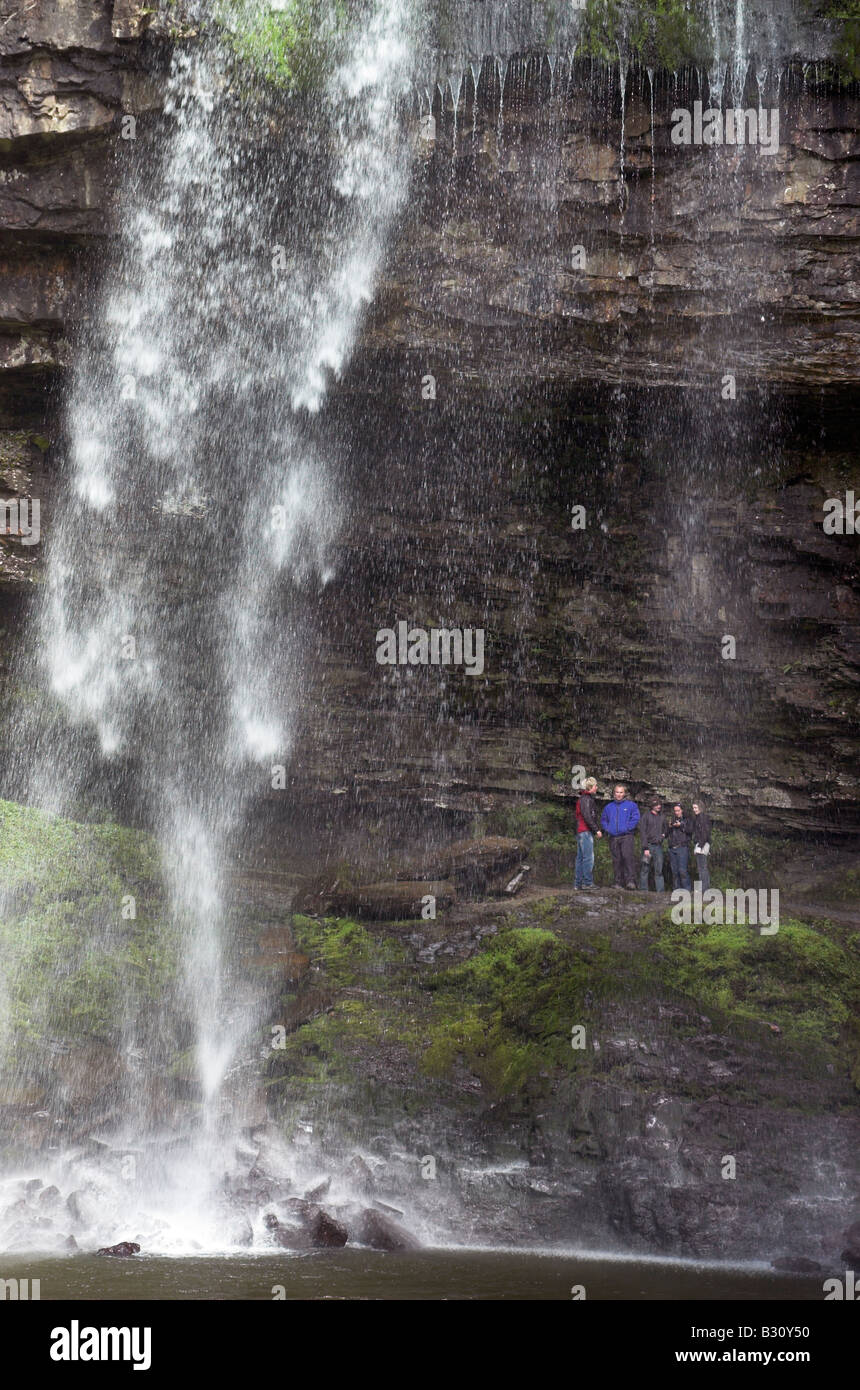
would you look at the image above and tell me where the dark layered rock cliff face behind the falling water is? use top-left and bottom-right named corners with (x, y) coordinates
top-left (0, 0), bottom-right (860, 834)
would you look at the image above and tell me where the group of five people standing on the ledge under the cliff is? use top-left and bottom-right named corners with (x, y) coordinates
top-left (574, 777), bottom-right (711, 892)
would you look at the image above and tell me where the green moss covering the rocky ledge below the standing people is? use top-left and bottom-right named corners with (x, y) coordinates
top-left (268, 894), bottom-right (860, 1099)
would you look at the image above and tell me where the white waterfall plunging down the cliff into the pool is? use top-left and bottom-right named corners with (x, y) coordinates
top-left (0, 0), bottom-right (413, 1245)
